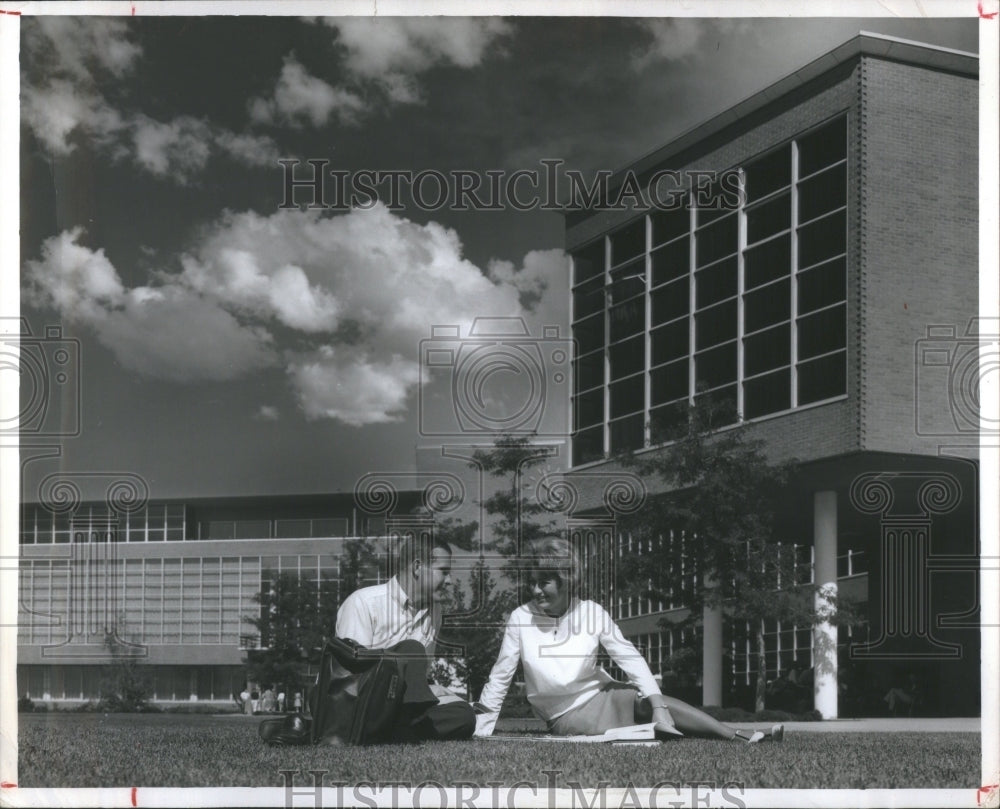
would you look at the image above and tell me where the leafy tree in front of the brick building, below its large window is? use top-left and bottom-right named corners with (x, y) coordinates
top-left (619, 400), bottom-right (861, 710)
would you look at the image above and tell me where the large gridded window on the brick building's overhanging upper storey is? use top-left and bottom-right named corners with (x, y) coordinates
top-left (572, 116), bottom-right (847, 465)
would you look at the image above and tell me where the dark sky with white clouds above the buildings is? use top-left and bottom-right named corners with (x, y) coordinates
top-left (11, 16), bottom-right (978, 499)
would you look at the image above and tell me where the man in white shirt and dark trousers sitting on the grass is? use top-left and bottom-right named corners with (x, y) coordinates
top-left (260, 535), bottom-right (476, 745)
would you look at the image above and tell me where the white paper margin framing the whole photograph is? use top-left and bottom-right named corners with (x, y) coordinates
top-left (0, 0), bottom-right (1000, 807)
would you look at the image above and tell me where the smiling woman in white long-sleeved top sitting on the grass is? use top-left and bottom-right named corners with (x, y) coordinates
top-left (474, 537), bottom-right (784, 743)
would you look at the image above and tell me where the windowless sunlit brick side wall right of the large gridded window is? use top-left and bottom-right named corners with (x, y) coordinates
top-left (859, 57), bottom-right (978, 455)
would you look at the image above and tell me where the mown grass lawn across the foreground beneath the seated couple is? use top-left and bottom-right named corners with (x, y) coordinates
top-left (18, 713), bottom-right (980, 789)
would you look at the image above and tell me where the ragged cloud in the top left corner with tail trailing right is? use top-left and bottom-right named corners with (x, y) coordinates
top-left (22, 16), bottom-right (278, 183)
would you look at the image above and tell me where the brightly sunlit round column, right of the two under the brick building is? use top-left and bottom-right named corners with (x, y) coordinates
top-left (813, 491), bottom-right (837, 719)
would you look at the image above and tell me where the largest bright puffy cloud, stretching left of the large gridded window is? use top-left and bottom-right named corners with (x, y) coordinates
top-left (25, 204), bottom-right (565, 426)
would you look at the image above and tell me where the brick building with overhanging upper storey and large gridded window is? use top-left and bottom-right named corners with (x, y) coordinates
top-left (566, 33), bottom-right (985, 717)
